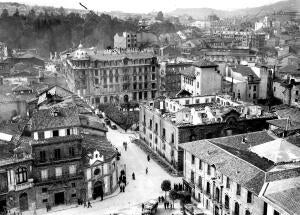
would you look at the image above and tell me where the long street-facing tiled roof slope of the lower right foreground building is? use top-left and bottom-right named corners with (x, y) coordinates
top-left (180, 140), bottom-right (265, 195)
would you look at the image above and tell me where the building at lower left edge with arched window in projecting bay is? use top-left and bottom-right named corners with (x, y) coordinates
top-left (0, 122), bottom-right (35, 214)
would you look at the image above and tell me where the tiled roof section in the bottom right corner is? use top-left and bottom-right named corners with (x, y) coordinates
top-left (265, 187), bottom-right (300, 215)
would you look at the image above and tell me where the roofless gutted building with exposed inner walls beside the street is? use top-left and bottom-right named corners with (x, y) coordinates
top-left (139, 94), bottom-right (275, 171)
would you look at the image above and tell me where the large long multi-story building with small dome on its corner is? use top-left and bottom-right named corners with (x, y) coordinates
top-left (62, 45), bottom-right (160, 105)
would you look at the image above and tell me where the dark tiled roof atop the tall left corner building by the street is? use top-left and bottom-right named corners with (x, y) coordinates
top-left (31, 106), bottom-right (80, 131)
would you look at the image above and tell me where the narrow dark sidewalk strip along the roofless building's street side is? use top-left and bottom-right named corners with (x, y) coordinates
top-left (132, 139), bottom-right (181, 177)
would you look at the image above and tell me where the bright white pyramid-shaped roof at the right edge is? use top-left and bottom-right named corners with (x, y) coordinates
top-left (250, 138), bottom-right (300, 163)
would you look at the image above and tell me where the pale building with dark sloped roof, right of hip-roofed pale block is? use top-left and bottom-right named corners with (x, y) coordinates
top-left (224, 65), bottom-right (272, 102)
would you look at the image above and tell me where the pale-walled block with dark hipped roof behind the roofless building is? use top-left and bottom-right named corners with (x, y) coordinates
top-left (180, 60), bottom-right (222, 96)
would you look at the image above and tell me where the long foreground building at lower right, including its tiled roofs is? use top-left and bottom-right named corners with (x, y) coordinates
top-left (181, 131), bottom-right (300, 215)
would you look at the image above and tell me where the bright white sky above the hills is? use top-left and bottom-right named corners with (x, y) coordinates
top-left (0, 0), bottom-right (286, 13)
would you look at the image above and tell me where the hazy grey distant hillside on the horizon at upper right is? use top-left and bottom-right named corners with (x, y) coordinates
top-left (169, 0), bottom-right (300, 19)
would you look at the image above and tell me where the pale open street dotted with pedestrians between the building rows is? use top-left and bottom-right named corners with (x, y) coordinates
top-left (48, 128), bottom-right (182, 215)
